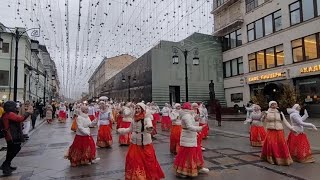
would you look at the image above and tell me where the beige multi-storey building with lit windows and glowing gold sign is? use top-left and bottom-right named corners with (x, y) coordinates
top-left (212, 0), bottom-right (320, 116)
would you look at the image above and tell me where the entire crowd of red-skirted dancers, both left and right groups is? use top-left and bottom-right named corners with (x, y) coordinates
top-left (39, 101), bottom-right (317, 179)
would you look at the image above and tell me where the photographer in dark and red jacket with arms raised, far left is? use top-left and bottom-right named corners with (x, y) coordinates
top-left (1, 101), bottom-right (33, 176)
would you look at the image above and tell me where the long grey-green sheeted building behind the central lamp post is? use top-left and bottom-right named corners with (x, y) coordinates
top-left (103, 33), bottom-right (225, 106)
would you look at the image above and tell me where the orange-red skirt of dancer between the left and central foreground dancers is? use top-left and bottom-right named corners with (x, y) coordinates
top-left (97, 125), bottom-right (112, 147)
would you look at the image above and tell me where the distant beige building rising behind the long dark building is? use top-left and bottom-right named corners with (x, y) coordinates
top-left (88, 54), bottom-right (136, 98)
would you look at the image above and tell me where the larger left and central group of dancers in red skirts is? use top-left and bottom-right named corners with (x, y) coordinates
top-left (53, 101), bottom-right (209, 179)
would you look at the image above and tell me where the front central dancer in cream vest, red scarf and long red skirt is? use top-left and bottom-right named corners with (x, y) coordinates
top-left (118, 103), bottom-right (164, 180)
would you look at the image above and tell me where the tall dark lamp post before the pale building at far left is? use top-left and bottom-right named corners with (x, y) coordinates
top-left (0, 27), bottom-right (40, 101)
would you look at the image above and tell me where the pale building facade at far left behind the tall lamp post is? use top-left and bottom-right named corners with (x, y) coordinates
top-left (0, 23), bottom-right (59, 102)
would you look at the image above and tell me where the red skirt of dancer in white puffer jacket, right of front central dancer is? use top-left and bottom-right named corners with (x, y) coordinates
top-left (173, 146), bottom-right (204, 177)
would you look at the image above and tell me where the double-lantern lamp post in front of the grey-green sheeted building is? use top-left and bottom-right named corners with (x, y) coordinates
top-left (172, 46), bottom-right (199, 102)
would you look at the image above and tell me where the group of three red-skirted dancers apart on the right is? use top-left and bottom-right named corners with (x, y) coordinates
top-left (245, 101), bottom-right (317, 166)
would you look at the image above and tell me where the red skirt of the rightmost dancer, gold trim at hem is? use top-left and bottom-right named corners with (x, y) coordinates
top-left (287, 132), bottom-right (315, 163)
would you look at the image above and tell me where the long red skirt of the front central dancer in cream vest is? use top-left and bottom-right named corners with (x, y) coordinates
top-left (125, 144), bottom-right (164, 180)
